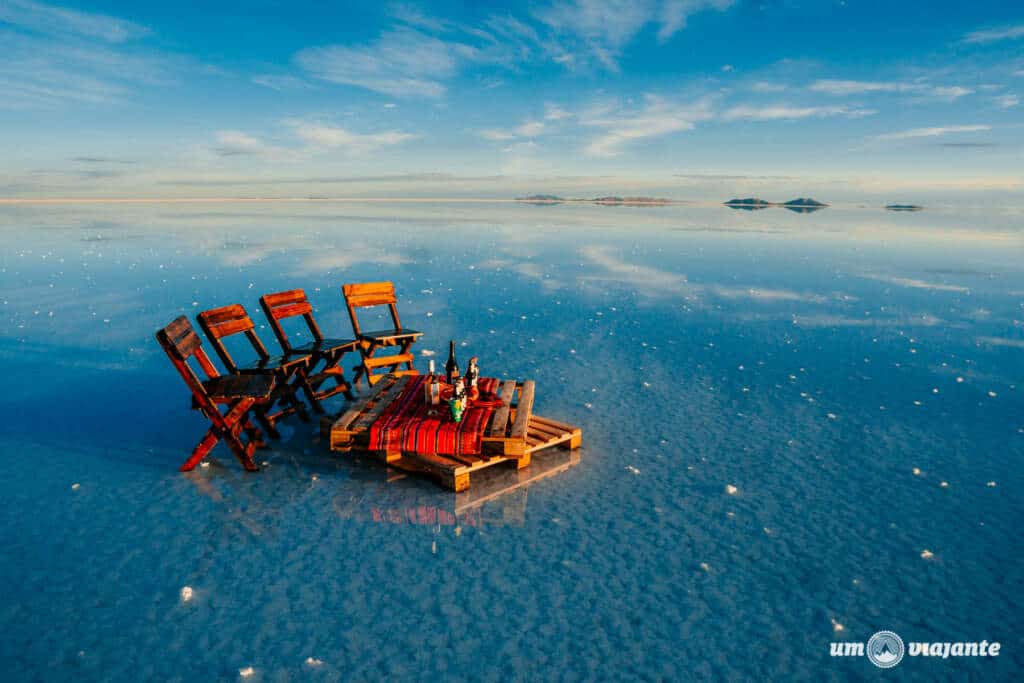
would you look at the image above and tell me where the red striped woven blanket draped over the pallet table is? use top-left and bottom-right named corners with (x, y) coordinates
top-left (370, 375), bottom-right (502, 456)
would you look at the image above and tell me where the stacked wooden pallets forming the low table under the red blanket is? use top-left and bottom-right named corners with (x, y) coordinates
top-left (323, 375), bottom-right (583, 492)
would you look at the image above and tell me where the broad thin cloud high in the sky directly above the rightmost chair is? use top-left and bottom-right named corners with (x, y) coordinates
top-left (295, 28), bottom-right (464, 97)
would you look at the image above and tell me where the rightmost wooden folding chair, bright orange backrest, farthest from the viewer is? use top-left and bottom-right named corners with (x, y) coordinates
top-left (341, 282), bottom-right (423, 386)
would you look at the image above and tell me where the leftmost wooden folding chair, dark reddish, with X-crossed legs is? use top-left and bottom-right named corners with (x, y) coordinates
top-left (157, 315), bottom-right (274, 472)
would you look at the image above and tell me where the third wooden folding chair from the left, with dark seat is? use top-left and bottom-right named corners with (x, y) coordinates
top-left (259, 290), bottom-right (358, 413)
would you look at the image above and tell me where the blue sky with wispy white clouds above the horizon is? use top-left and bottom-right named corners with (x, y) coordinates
top-left (0, 0), bottom-right (1024, 203)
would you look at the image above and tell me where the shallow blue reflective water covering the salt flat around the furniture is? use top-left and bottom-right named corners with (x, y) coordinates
top-left (0, 203), bottom-right (1024, 681)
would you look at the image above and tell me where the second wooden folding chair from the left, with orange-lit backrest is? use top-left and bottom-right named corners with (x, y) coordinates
top-left (197, 303), bottom-right (309, 438)
